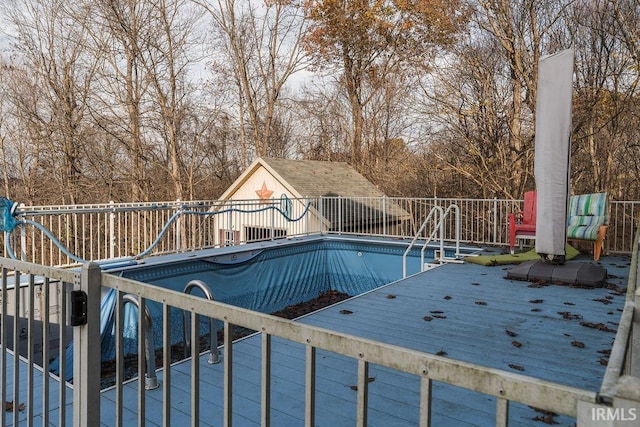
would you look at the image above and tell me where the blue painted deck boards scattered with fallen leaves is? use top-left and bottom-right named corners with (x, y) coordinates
top-left (102, 256), bottom-right (629, 427)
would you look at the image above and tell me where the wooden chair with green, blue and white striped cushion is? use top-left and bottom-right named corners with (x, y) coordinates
top-left (567, 193), bottom-right (609, 261)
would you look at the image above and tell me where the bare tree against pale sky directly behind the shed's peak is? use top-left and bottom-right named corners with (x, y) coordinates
top-left (198, 0), bottom-right (308, 165)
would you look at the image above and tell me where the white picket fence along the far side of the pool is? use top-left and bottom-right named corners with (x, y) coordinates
top-left (0, 197), bottom-right (640, 265)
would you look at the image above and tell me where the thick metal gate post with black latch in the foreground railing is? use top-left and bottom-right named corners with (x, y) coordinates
top-left (71, 263), bottom-right (102, 427)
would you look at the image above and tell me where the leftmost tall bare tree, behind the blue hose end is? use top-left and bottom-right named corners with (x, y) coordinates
top-left (4, 0), bottom-right (94, 203)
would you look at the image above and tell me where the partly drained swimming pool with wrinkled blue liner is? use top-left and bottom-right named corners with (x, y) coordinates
top-left (101, 235), bottom-right (470, 360)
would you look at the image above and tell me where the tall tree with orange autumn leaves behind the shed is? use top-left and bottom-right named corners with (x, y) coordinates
top-left (306, 0), bottom-right (467, 166)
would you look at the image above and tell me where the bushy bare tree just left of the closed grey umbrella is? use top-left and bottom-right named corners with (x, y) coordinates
top-left (421, 36), bottom-right (533, 197)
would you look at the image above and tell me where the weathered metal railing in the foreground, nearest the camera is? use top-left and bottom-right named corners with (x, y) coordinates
top-left (0, 252), bottom-right (638, 426)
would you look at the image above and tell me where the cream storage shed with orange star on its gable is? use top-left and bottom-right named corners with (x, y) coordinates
top-left (216, 158), bottom-right (409, 246)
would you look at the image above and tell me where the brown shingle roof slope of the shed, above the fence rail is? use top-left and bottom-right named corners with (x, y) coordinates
top-left (262, 158), bottom-right (384, 197)
